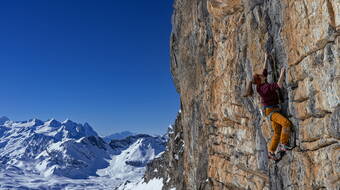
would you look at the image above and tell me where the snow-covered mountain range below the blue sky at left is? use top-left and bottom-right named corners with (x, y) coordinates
top-left (0, 117), bottom-right (166, 189)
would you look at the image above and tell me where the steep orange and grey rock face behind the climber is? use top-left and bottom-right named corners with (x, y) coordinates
top-left (146, 0), bottom-right (340, 190)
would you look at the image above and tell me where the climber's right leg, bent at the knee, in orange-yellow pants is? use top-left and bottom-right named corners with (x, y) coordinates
top-left (271, 112), bottom-right (292, 145)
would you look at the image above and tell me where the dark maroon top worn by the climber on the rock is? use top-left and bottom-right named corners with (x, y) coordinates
top-left (256, 69), bottom-right (280, 106)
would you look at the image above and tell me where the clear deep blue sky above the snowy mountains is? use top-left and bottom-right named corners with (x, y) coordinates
top-left (0, 0), bottom-right (179, 135)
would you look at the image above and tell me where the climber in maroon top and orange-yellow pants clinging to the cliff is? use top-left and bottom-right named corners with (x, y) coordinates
top-left (244, 56), bottom-right (292, 160)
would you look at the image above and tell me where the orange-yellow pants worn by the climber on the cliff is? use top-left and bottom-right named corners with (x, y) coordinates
top-left (265, 108), bottom-right (292, 152)
